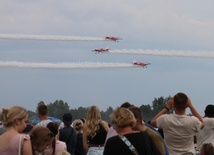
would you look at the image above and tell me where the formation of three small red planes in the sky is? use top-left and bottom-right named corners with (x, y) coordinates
top-left (92, 36), bottom-right (151, 68)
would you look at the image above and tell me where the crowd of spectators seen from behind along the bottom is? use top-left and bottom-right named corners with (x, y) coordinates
top-left (0, 92), bottom-right (214, 155)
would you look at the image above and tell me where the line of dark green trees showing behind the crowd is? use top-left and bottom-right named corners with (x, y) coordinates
top-left (29, 96), bottom-right (170, 123)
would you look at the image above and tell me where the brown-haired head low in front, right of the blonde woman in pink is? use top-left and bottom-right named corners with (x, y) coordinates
top-left (30, 126), bottom-right (54, 152)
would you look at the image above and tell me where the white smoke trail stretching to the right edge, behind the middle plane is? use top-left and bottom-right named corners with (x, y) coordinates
top-left (109, 49), bottom-right (214, 59)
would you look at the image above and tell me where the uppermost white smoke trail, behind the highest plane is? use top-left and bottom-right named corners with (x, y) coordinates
top-left (0, 34), bottom-right (105, 41)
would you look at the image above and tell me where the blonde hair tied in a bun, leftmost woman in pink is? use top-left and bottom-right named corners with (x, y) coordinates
top-left (1, 106), bottom-right (28, 128)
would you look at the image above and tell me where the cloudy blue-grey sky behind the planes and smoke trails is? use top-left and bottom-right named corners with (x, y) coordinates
top-left (0, 0), bottom-right (214, 115)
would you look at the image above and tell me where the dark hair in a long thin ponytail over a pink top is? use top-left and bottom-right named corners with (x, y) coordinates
top-left (47, 122), bottom-right (59, 155)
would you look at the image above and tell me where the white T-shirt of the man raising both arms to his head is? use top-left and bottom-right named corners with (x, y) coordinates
top-left (156, 114), bottom-right (201, 155)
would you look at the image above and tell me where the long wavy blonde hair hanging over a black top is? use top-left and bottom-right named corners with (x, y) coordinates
top-left (86, 106), bottom-right (101, 138)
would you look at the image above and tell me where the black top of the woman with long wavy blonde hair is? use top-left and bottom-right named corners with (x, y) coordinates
top-left (87, 123), bottom-right (107, 145)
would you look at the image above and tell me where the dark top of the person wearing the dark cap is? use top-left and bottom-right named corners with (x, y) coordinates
top-left (59, 126), bottom-right (77, 154)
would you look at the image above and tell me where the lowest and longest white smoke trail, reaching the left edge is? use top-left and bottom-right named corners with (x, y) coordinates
top-left (0, 61), bottom-right (139, 69)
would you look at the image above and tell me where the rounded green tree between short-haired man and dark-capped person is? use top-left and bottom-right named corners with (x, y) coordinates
top-left (47, 100), bottom-right (70, 119)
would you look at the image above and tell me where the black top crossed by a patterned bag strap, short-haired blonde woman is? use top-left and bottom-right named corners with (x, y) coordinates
top-left (103, 132), bottom-right (160, 155)
